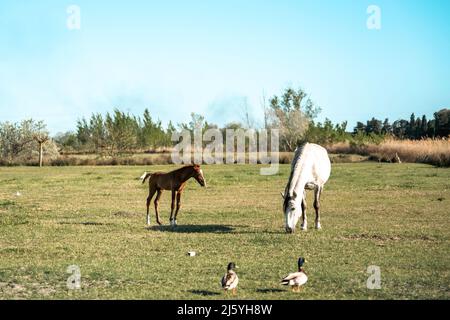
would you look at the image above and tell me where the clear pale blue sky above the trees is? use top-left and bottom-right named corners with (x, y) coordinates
top-left (0, 0), bottom-right (450, 134)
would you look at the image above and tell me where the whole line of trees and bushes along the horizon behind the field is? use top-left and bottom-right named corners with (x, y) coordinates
top-left (0, 88), bottom-right (450, 163)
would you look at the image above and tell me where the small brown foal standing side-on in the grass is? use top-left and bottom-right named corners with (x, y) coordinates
top-left (142, 164), bottom-right (206, 226)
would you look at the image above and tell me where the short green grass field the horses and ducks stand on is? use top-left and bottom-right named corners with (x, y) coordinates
top-left (0, 162), bottom-right (450, 299)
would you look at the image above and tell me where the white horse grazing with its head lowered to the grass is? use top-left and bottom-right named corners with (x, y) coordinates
top-left (281, 143), bottom-right (331, 233)
